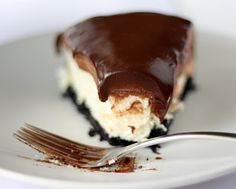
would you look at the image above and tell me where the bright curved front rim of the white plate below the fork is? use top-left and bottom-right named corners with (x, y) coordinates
top-left (0, 161), bottom-right (236, 189)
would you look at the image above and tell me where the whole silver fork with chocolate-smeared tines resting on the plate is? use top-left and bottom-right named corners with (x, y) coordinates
top-left (14, 124), bottom-right (236, 168)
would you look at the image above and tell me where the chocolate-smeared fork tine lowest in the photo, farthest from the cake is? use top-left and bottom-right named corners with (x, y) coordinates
top-left (15, 131), bottom-right (97, 167)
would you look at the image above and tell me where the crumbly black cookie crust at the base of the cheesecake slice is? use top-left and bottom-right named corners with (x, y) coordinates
top-left (63, 78), bottom-right (195, 146)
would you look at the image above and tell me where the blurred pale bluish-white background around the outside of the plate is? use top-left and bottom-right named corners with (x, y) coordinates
top-left (0, 0), bottom-right (236, 189)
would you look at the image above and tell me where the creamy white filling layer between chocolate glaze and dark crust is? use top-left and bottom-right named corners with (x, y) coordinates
top-left (59, 52), bottom-right (184, 141)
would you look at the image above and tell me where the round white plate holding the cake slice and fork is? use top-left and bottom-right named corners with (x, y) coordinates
top-left (0, 33), bottom-right (236, 188)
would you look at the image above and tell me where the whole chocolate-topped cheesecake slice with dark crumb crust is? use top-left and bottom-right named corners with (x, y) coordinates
top-left (56, 12), bottom-right (193, 145)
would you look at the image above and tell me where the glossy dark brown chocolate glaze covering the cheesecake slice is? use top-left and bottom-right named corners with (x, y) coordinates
top-left (57, 12), bottom-right (192, 120)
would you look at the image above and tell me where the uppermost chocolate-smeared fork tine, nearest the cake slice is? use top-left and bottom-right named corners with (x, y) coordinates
top-left (23, 124), bottom-right (106, 156)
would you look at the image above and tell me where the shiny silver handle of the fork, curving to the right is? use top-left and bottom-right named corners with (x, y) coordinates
top-left (121, 131), bottom-right (236, 156)
